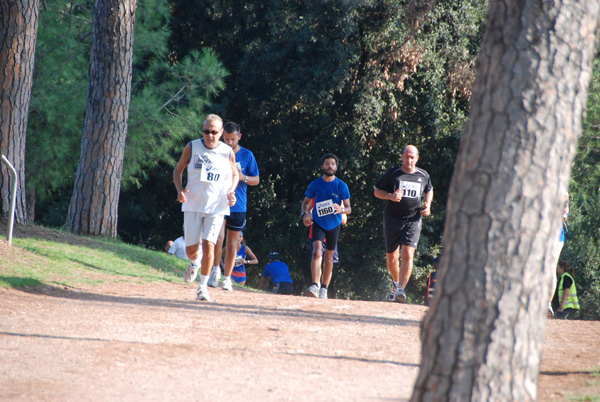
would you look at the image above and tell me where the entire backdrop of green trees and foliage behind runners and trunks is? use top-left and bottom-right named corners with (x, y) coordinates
top-left (27, 0), bottom-right (600, 319)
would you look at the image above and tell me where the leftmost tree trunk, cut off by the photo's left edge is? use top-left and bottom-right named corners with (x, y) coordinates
top-left (0, 0), bottom-right (40, 223)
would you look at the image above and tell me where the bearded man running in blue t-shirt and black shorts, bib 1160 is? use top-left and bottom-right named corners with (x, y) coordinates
top-left (302, 154), bottom-right (352, 299)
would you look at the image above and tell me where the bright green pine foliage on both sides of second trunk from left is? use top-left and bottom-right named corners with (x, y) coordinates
top-left (27, 0), bottom-right (227, 227)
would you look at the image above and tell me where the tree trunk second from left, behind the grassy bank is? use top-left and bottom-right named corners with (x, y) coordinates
top-left (66, 0), bottom-right (136, 237)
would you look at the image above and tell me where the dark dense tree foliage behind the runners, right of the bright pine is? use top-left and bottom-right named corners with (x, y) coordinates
top-left (165, 0), bottom-right (487, 300)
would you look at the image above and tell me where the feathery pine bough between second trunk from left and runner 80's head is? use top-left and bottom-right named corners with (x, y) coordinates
top-left (123, 48), bottom-right (227, 188)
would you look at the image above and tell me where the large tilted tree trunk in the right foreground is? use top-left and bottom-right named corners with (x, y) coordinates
top-left (411, 0), bottom-right (600, 401)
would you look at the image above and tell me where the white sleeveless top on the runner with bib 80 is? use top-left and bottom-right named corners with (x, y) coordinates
top-left (181, 139), bottom-right (233, 215)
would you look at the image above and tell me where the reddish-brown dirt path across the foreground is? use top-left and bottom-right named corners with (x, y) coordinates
top-left (0, 283), bottom-right (600, 402)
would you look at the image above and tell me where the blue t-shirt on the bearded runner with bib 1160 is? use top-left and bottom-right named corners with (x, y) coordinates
top-left (304, 177), bottom-right (350, 230)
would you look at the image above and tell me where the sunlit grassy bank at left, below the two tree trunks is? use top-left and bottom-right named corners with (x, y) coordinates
top-left (0, 235), bottom-right (187, 288)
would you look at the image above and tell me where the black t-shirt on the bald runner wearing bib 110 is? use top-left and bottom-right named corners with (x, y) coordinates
top-left (375, 165), bottom-right (433, 219)
